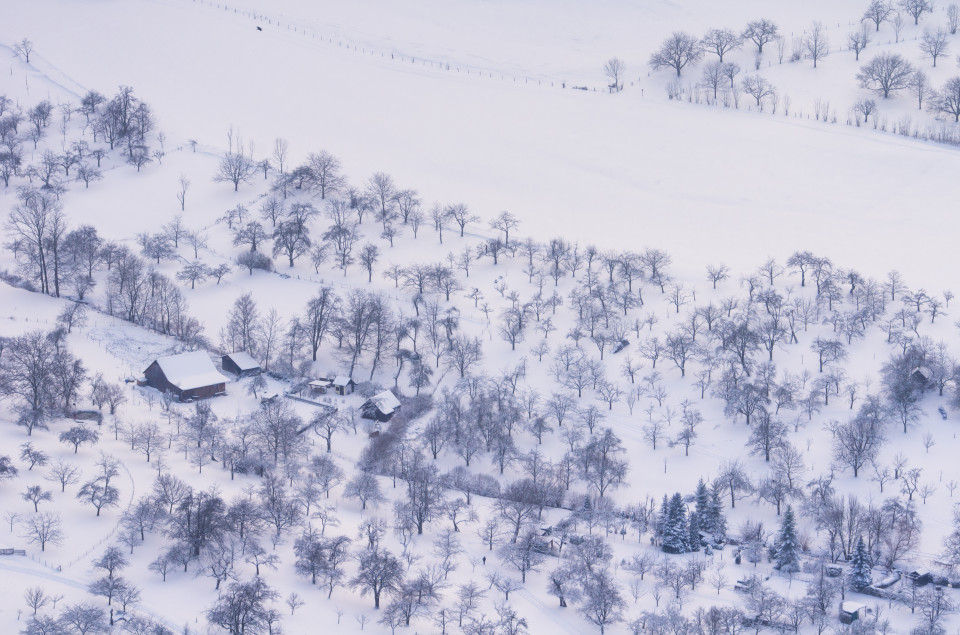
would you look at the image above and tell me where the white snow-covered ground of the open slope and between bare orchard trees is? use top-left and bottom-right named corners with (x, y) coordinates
top-left (0, 0), bottom-right (960, 633)
